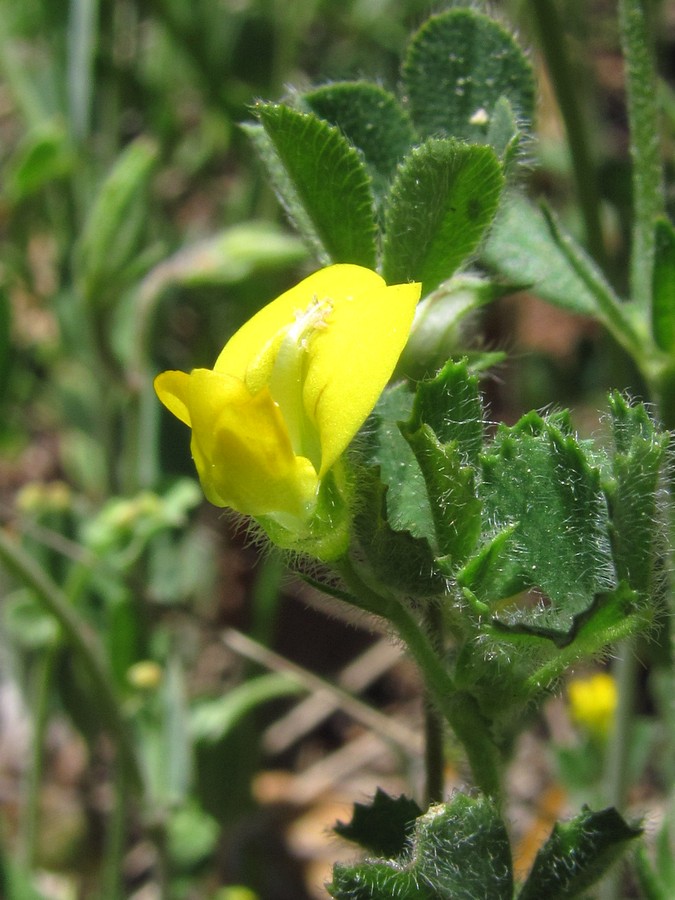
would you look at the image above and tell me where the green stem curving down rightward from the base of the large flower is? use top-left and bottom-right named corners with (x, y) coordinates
top-left (336, 557), bottom-right (501, 799)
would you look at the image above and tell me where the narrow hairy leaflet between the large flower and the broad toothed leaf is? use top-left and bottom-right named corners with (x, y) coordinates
top-left (401, 425), bottom-right (481, 566)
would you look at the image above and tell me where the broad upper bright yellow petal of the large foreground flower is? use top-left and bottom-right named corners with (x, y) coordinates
top-left (214, 264), bottom-right (421, 477)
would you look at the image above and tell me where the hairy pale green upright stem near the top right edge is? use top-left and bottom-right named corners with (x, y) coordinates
top-left (619, 0), bottom-right (664, 314)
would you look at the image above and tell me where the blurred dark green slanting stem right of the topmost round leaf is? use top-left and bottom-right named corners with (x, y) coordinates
top-left (528, 0), bottom-right (606, 267)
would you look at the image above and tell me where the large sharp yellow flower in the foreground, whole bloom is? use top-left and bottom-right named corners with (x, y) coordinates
top-left (155, 265), bottom-right (420, 552)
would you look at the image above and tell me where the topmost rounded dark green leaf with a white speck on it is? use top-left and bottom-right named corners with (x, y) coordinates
top-left (403, 9), bottom-right (535, 143)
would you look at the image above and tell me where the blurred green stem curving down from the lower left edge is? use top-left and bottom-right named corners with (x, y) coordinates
top-left (0, 530), bottom-right (143, 789)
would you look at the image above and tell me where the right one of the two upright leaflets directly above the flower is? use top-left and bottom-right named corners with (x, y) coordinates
top-left (382, 140), bottom-right (504, 296)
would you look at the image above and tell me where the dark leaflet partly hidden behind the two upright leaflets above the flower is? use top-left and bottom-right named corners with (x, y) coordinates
top-left (302, 81), bottom-right (415, 195)
